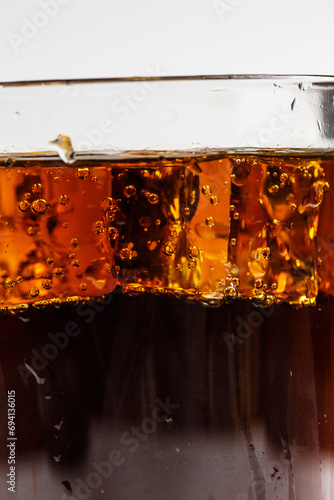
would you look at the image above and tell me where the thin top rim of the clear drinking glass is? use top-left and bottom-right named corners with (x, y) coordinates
top-left (0, 73), bottom-right (334, 87)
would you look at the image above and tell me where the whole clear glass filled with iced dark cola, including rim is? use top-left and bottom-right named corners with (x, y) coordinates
top-left (0, 75), bottom-right (334, 500)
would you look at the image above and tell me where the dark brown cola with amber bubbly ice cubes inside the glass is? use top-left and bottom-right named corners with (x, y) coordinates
top-left (0, 156), bottom-right (334, 500)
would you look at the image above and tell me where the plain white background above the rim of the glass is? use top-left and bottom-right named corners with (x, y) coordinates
top-left (0, 0), bottom-right (334, 81)
